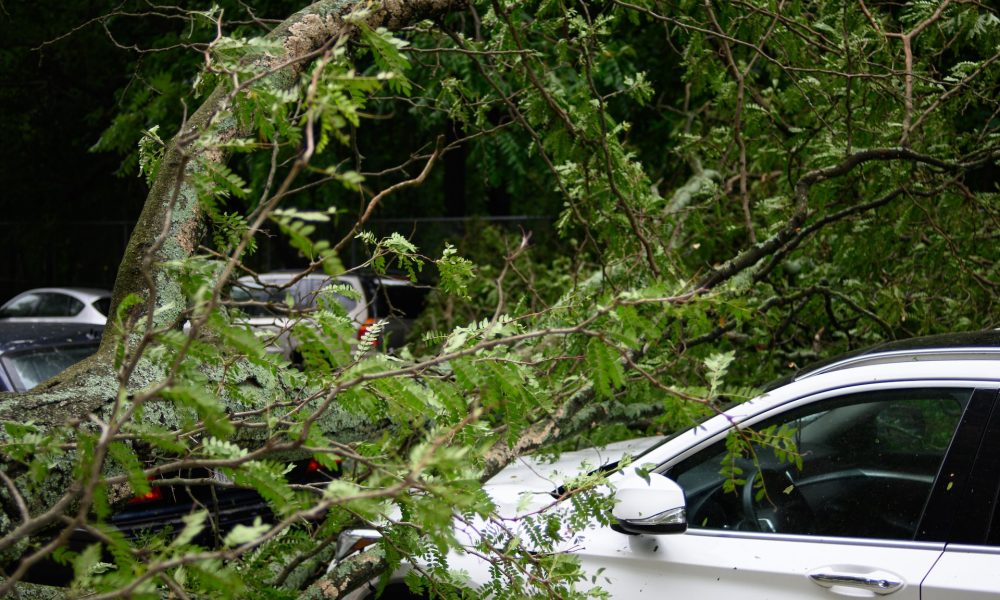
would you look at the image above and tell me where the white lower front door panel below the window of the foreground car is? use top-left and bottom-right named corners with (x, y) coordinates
top-left (576, 528), bottom-right (944, 600)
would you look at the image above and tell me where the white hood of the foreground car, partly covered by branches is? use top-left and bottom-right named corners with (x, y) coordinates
top-left (484, 437), bottom-right (663, 516)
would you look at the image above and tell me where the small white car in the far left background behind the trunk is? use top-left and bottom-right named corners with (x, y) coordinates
top-left (0, 287), bottom-right (111, 325)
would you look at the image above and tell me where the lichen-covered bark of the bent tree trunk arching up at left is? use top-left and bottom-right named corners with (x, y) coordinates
top-left (0, 0), bottom-right (465, 450)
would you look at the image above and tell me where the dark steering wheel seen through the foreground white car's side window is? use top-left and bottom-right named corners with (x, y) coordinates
top-left (741, 468), bottom-right (815, 533)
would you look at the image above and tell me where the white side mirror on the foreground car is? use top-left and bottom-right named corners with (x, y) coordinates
top-left (611, 471), bottom-right (687, 534)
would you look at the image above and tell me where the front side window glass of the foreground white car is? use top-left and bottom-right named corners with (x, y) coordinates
top-left (667, 388), bottom-right (972, 540)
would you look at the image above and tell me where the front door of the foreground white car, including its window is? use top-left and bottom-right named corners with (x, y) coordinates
top-left (580, 383), bottom-right (992, 600)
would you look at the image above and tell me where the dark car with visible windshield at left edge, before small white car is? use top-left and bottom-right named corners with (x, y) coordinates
top-left (0, 321), bottom-right (104, 392)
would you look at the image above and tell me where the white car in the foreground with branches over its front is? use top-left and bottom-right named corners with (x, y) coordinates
top-left (343, 330), bottom-right (1000, 600)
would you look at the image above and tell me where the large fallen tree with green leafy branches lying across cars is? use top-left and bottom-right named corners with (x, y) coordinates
top-left (0, 0), bottom-right (1000, 597)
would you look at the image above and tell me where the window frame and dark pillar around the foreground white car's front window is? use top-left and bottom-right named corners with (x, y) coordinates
top-left (653, 379), bottom-right (1000, 545)
